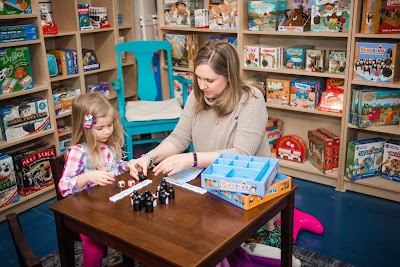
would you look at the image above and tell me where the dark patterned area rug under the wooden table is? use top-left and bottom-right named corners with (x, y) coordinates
top-left (42, 242), bottom-right (354, 267)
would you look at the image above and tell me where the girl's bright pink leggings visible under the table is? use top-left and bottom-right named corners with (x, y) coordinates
top-left (79, 234), bottom-right (105, 267)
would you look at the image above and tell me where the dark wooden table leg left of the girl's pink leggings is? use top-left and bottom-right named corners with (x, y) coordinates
top-left (54, 212), bottom-right (75, 267)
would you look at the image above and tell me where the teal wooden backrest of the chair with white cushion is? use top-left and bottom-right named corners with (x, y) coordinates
top-left (115, 40), bottom-right (175, 118)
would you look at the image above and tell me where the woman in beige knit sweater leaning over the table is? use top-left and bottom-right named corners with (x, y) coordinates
top-left (129, 41), bottom-right (271, 178)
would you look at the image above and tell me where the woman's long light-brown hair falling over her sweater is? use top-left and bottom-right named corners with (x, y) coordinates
top-left (193, 40), bottom-right (264, 116)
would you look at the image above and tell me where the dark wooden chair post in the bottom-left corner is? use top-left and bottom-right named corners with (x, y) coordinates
top-left (6, 213), bottom-right (42, 267)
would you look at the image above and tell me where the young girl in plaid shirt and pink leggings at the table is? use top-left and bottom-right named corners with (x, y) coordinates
top-left (58, 93), bottom-right (136, 267)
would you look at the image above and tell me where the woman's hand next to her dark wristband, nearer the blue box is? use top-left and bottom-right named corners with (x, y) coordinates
top-left (153, 153), bottom-right (193, 176)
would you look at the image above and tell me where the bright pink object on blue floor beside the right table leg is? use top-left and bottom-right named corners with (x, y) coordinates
top-left (276, 209), bottom-right (324, 243)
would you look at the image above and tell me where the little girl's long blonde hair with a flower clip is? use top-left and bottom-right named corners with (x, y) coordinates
top-left (71, 93), bottom-right (124, 170)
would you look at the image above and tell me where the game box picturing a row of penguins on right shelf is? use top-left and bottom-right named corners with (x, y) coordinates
top-left (353, 42), bottom-right (400, 83)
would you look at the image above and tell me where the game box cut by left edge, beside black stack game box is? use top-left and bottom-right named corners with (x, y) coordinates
top-left (0, 153), bottom-right (19, 208)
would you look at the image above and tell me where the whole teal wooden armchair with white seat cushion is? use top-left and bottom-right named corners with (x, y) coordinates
top-left (111, 41), bottom-right (192, 159)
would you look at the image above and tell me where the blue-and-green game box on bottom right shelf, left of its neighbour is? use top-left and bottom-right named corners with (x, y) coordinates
top-left (345, 137), bottom-right (386, 180)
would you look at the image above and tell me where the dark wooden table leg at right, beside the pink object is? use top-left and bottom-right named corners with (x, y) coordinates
top-left (281, 191), bottom-right (294, 267)
